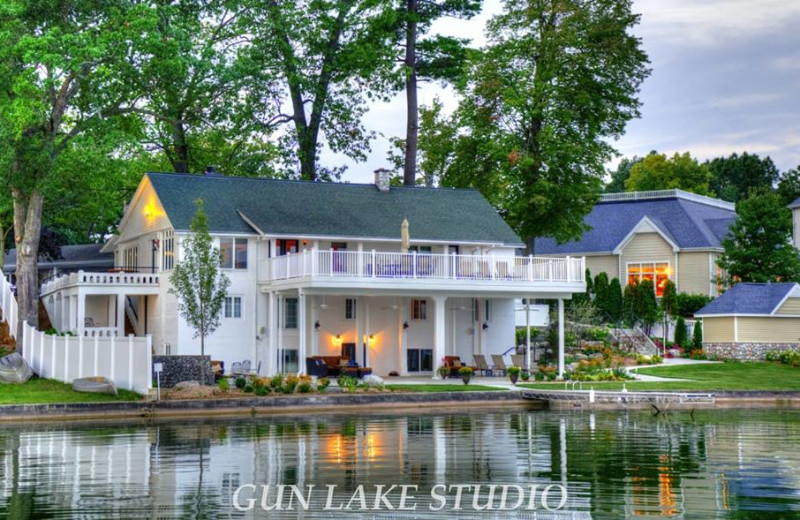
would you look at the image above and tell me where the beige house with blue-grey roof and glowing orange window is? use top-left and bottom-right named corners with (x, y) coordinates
top-left (534, 190), bottom-right (736, 296)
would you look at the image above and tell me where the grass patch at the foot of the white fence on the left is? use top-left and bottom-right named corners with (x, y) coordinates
top-left (0, 378), bottom-right (142, 405)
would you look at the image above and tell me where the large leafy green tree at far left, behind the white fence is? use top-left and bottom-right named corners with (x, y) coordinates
top-left (0, 0), bottom-right (139, 340)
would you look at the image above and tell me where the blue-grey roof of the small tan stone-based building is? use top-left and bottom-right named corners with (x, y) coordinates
top-left (694, 282), bottom-right (797, 316)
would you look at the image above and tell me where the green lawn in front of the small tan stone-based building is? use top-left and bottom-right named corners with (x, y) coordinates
top-left (520, 363), bottom-right (800, 391)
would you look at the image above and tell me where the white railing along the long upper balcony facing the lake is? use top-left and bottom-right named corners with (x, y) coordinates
top-left (260, 250), bottom-right (586, 282)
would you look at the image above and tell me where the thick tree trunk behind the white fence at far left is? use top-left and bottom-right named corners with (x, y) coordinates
top-left (12, 188), bottom-right (43, 354)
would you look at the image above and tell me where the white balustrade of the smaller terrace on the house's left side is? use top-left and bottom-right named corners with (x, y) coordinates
top-left (41, 268), bottom-right (160, 296)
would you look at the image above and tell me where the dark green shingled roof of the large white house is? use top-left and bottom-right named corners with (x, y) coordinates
top-left (148, 173), bottom-right (522, 246)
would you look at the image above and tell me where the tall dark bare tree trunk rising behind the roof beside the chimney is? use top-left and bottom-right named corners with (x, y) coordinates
top-left (403, 0), bottom-right (419, 186)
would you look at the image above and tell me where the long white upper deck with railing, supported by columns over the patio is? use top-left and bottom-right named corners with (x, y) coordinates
top-left (259, 250), bottom-right (586, 293)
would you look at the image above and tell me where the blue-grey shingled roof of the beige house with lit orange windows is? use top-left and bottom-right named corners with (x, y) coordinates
top-left (534, 196), bottom-right (736, 255)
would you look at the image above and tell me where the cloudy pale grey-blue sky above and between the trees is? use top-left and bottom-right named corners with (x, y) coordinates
top-left (323, 0), bottom-right (800, 182)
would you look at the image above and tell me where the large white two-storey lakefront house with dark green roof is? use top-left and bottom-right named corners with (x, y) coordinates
top-left (37, 172), bottom-right (585, 375)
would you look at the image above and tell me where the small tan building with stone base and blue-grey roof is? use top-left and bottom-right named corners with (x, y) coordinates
top-left (695, 282), bottom-right (800, 360)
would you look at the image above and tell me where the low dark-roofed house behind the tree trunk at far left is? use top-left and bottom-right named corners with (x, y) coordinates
top-left (3, 244), bottom-right (114, 281)
